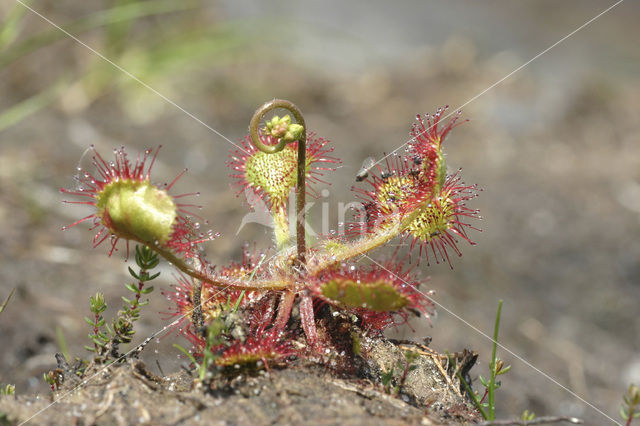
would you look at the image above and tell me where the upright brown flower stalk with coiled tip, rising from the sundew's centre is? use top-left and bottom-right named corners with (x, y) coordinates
top-left (249, 99), bottom-right (307, 265)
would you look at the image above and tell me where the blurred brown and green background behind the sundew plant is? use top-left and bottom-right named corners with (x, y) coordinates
top-left (0, 0), bottom-right (640, 424)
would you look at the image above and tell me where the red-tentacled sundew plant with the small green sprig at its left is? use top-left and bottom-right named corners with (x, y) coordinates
top-left (62, 96), bottom-right (479, 369)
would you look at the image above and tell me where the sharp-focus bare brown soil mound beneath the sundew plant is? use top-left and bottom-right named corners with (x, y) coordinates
top-left (0, 339), bottom-right (479, 425)
